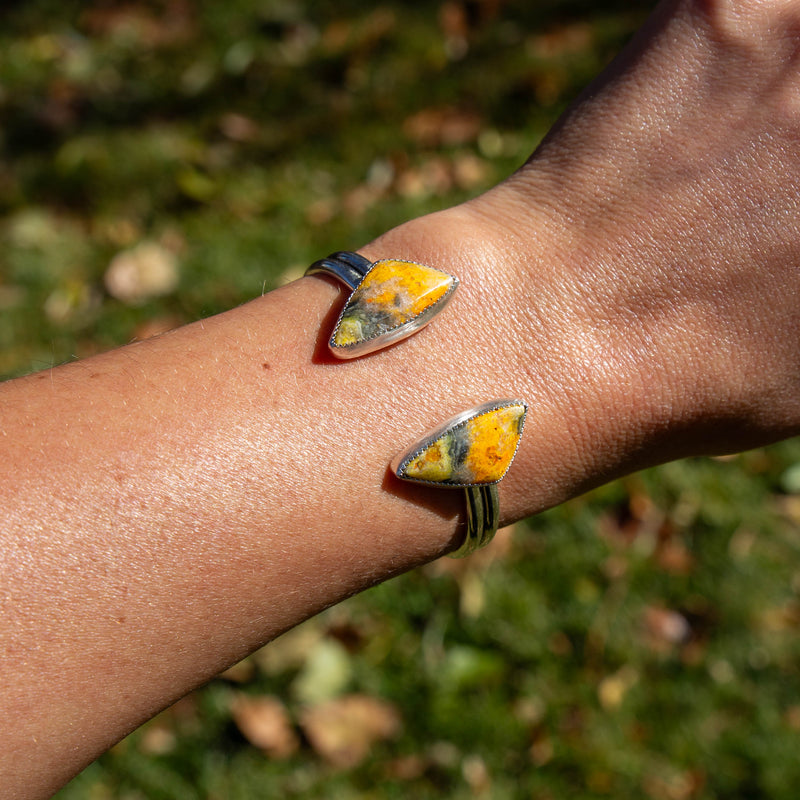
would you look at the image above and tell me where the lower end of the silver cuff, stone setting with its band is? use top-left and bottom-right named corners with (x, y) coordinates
top-left (391, 400), bottom-right (528, 557)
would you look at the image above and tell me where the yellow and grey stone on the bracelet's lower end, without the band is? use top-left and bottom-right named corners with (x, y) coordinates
top-left (397, 403), bottom-right (527, 486)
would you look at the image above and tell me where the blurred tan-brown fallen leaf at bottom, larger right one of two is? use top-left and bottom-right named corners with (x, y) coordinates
top-left (300, 694), bottom-right (401, 769)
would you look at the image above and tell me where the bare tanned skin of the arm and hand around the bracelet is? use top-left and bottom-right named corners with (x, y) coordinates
top-left (0, 0), bottom-right (800, 798)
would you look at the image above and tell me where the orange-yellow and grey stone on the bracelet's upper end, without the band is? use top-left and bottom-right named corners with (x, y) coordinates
top-left (331, 259), bottom-right (455, 347)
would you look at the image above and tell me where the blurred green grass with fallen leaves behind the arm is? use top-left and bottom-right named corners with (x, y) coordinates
top-left (0, 0), bottom-right (800, 800)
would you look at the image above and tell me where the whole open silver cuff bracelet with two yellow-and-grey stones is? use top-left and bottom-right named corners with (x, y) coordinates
top-left (306, 251), bottom-right (528, 557)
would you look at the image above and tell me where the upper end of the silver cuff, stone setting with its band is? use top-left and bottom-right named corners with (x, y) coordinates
top-left (306, 251), bottom-right (458, 358)
